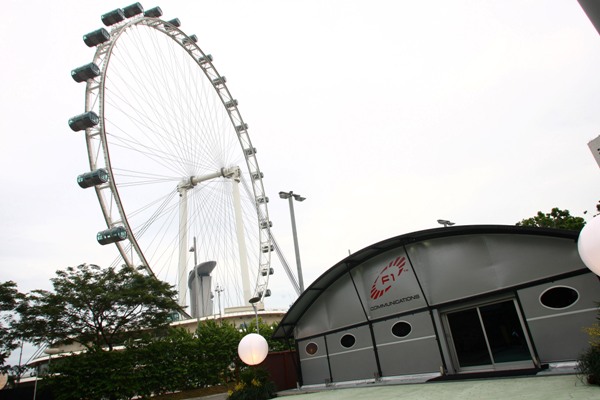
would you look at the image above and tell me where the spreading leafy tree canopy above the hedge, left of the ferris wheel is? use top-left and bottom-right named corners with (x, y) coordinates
top-left (18, 264), bottom-right (178, 350)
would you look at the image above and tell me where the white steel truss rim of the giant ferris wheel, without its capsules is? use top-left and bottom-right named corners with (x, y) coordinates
top-left (79, 11), bottom-right (271, 306)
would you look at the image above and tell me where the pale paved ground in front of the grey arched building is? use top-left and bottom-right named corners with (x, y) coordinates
top-left (280, 375), bottom-right (600, 400)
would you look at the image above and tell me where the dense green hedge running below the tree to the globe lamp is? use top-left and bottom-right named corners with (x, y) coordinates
top-left (41, 320), bottom-right (286, 400)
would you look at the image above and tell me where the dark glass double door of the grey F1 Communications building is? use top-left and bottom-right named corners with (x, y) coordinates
top-left (445, 300), bottom-right (534, 370)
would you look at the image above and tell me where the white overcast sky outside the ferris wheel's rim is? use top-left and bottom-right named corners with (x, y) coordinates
top-left (0, 0), bottom-right (600, 324)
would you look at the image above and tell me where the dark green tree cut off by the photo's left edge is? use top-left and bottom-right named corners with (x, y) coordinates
top-left (0, 281), bottom-right (22, 371)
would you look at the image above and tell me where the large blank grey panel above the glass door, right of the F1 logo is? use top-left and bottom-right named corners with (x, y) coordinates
top-left (407, 234), bottom-right (584, 305)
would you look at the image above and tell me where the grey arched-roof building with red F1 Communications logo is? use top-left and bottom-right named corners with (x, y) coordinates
top-left (275, 226), bottom-right (600, 385)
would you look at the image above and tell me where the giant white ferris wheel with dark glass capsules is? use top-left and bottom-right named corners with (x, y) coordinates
top-left (69, 3), bottom-right (273, 312)
